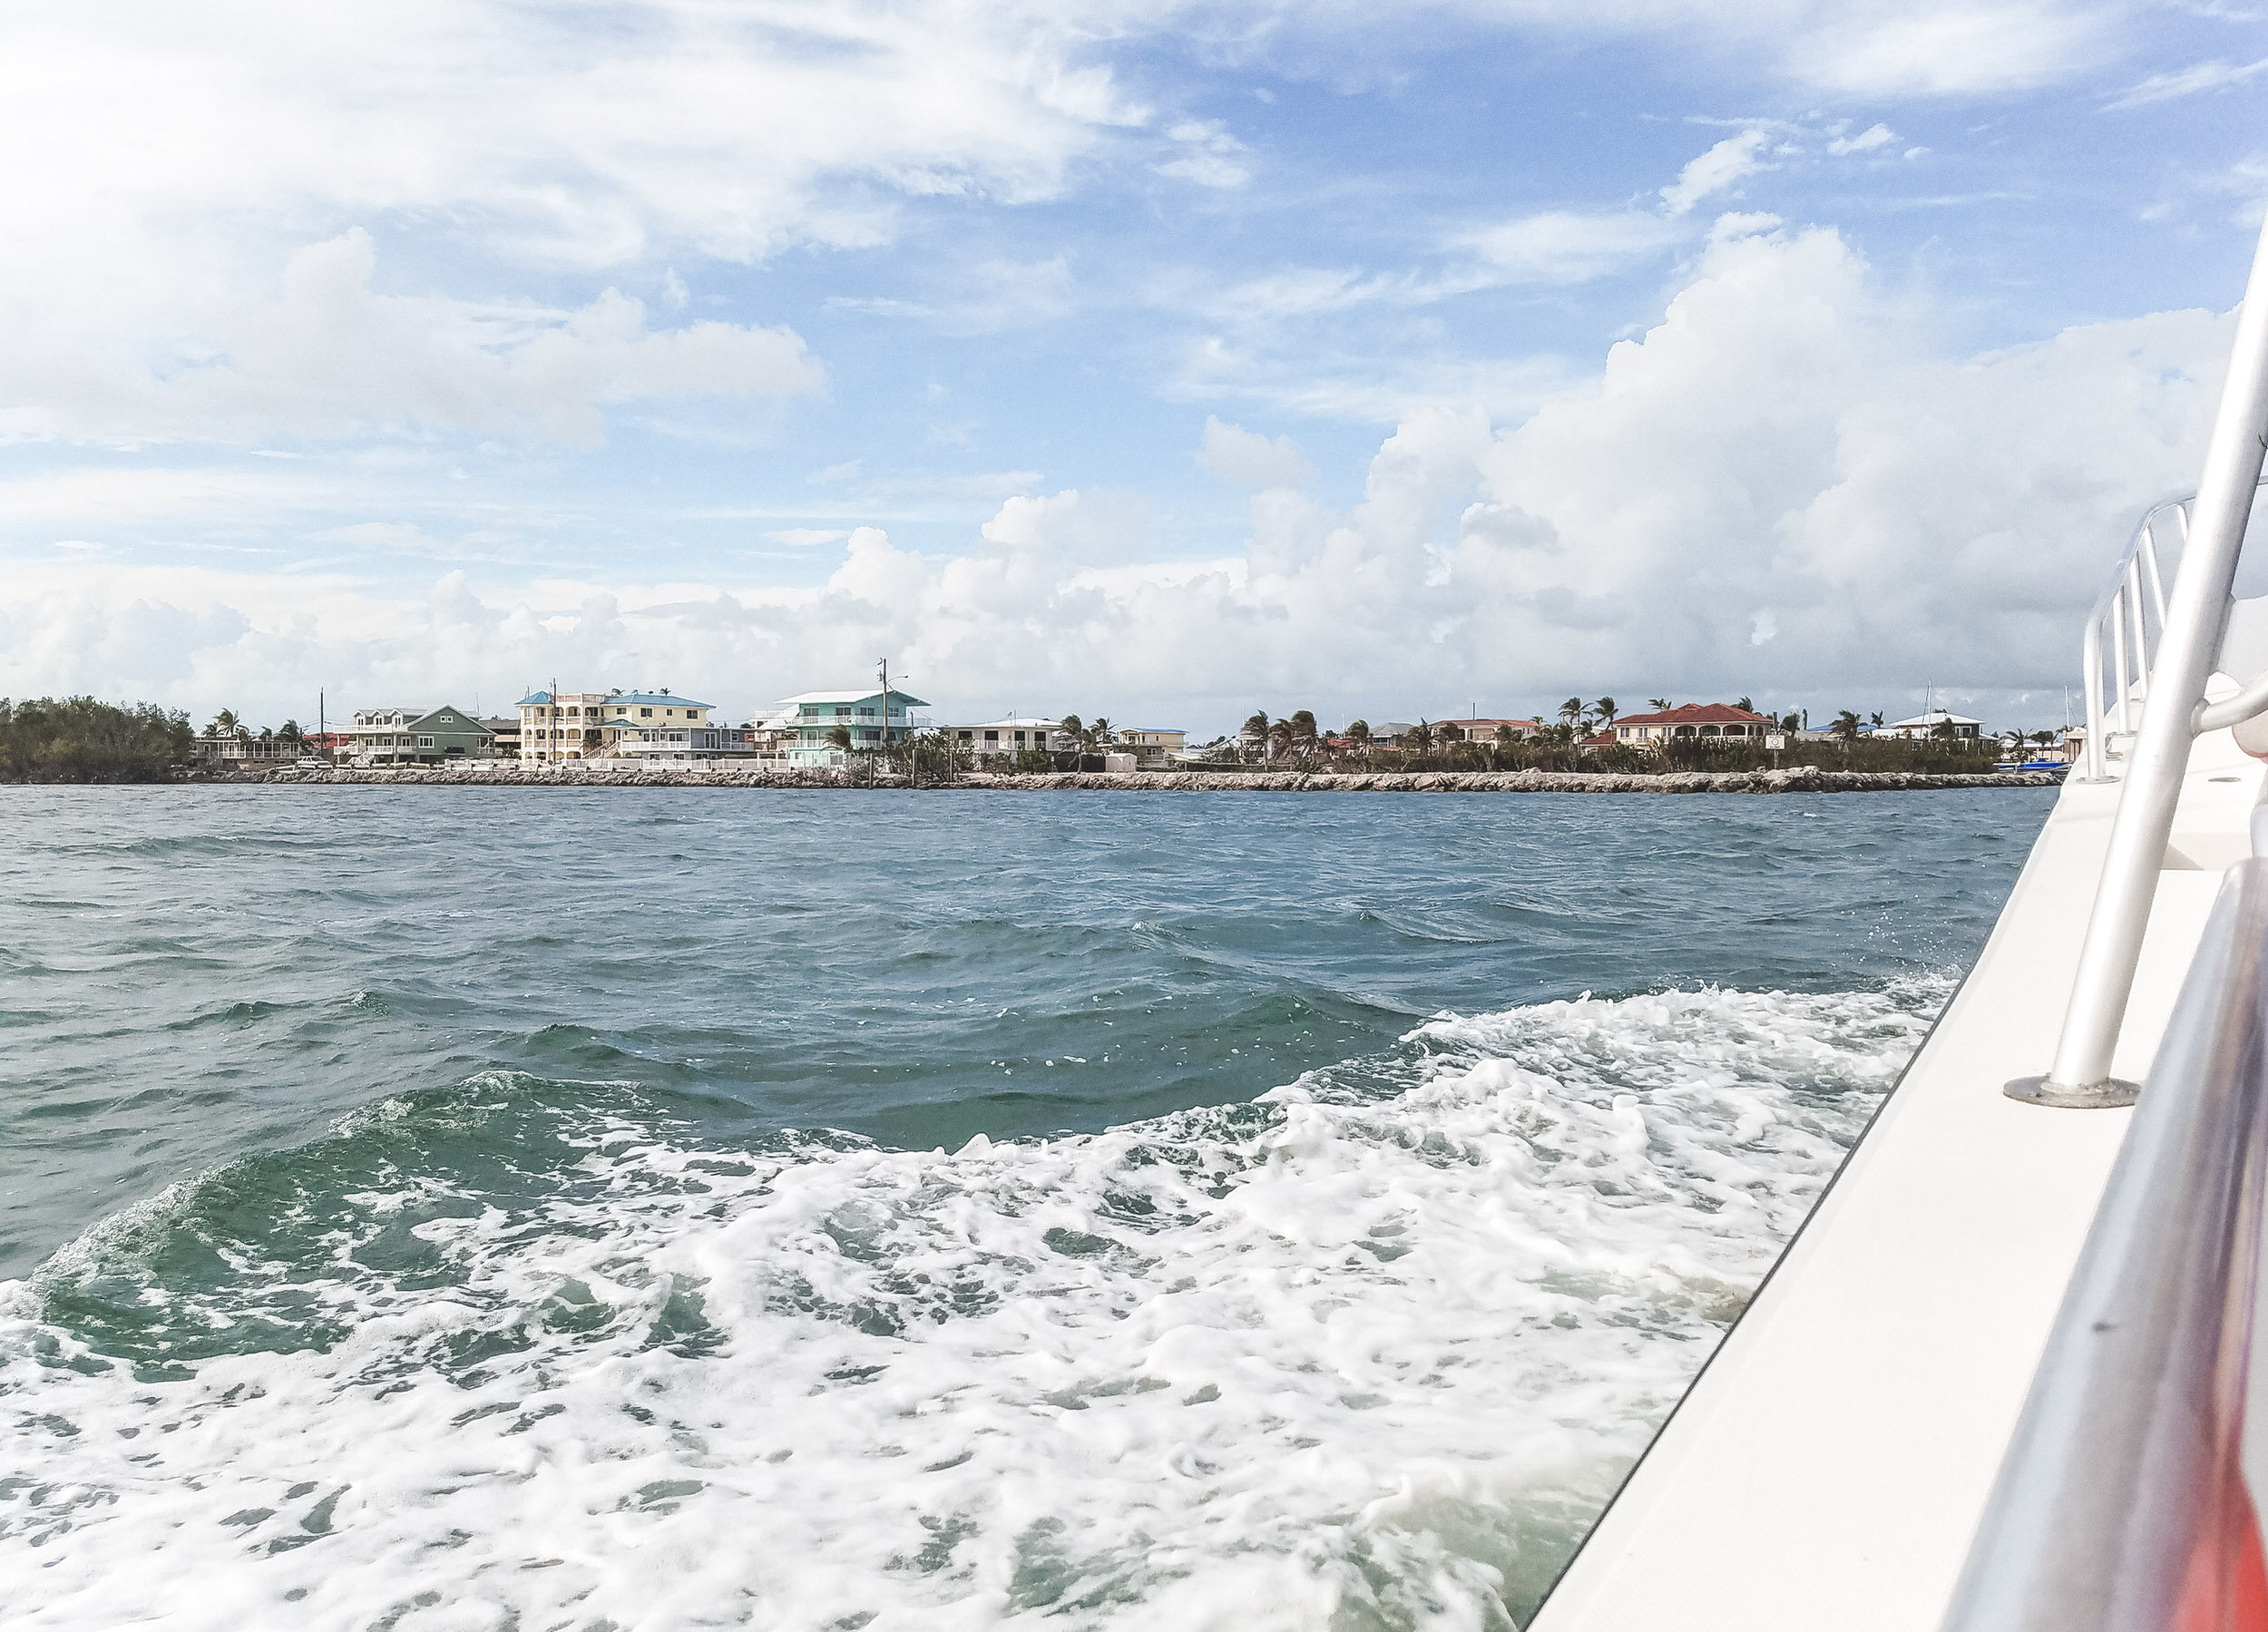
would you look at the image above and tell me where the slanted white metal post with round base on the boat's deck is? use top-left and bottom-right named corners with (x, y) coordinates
top-left (2008, 210), bottom-right (2268, 1106)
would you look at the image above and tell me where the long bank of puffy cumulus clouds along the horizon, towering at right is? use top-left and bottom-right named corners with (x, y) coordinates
top-left (0, 229), bottom-right (2230, 726)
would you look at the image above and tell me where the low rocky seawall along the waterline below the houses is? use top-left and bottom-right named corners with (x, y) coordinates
top-left (189, 764), bottom-right (2055, 794)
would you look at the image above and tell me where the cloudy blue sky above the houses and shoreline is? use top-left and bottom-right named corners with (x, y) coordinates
top-left (0, 0), bottom-right (2268, 737)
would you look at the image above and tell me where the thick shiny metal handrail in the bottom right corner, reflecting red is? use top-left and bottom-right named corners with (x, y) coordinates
top-left (1944, 861), bottom-right (2268, 1632)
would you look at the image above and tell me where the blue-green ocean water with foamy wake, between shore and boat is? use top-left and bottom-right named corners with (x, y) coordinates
top-left (0, 787), bottom-right (2053, 1632)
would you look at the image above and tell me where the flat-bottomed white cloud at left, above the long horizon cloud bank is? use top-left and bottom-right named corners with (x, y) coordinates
top-left (0, 229), bottom-right (824, 442)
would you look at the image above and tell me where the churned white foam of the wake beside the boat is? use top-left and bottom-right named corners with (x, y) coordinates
top-left (0, 991), bottom-right (1941, 1632)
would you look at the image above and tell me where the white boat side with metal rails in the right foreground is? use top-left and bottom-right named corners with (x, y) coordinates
top-left (1531, 210), bottom-right (2268, 1632)
